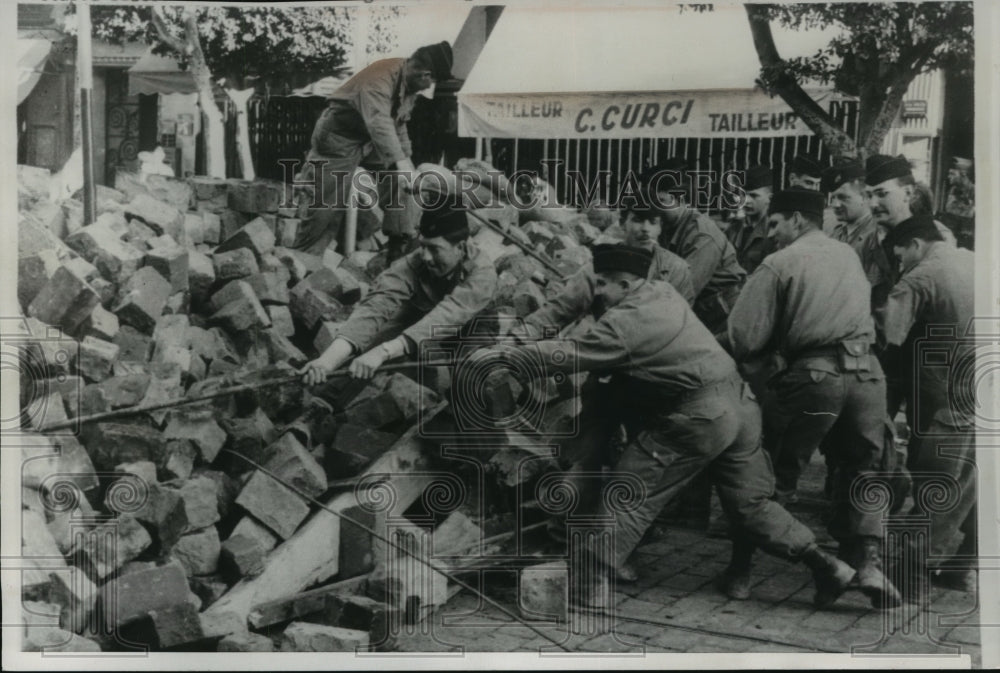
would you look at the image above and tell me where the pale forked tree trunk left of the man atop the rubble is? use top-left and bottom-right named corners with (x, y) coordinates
top-left (153, 6), bottom-right (226, 178)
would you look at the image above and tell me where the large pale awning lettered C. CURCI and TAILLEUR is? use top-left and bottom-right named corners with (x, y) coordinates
top-left (458, 5), bottom-right (834, 139)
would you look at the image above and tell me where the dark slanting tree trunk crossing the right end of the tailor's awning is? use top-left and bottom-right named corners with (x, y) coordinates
top-left (745, 4), bottom-right (858, 158)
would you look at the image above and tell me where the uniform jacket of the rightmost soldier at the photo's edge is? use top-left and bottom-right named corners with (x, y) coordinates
top-left (879, 242), bottom-right (975, 429)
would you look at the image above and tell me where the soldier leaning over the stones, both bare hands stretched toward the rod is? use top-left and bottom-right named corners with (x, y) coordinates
top-left (302, 201), bottom-right (497, 385)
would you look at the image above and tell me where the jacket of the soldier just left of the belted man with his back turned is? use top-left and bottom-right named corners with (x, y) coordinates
top-left (660, 209), bottom-right (746, 299)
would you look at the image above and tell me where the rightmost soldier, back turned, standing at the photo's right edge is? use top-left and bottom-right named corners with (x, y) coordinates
top-left (882, 215), bottom-right (977, 591)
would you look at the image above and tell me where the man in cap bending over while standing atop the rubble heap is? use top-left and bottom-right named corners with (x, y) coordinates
top-left (295, 42), bottom-right (452, 261)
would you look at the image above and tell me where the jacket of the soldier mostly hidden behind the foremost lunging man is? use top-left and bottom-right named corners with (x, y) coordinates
top-left (524, 245), bottom-right (694, 335)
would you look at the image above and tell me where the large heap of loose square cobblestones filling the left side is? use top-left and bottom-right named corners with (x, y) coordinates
top-left (17, 159), bottom-right (600, 651)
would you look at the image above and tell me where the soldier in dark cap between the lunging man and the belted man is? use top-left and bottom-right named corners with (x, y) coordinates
top-left (640, 168), bottom-right (746, 334)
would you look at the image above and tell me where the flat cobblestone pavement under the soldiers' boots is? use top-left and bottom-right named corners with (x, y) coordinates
top-left (397, 446), bottom-right (980, 667)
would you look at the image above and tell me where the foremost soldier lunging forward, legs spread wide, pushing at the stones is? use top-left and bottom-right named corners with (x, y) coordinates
top-left (508, 245), bottom-right (854, 604)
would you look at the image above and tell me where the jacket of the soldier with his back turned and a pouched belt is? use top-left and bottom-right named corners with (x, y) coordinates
top-left (728, 230), bottom-right (875, 361)
